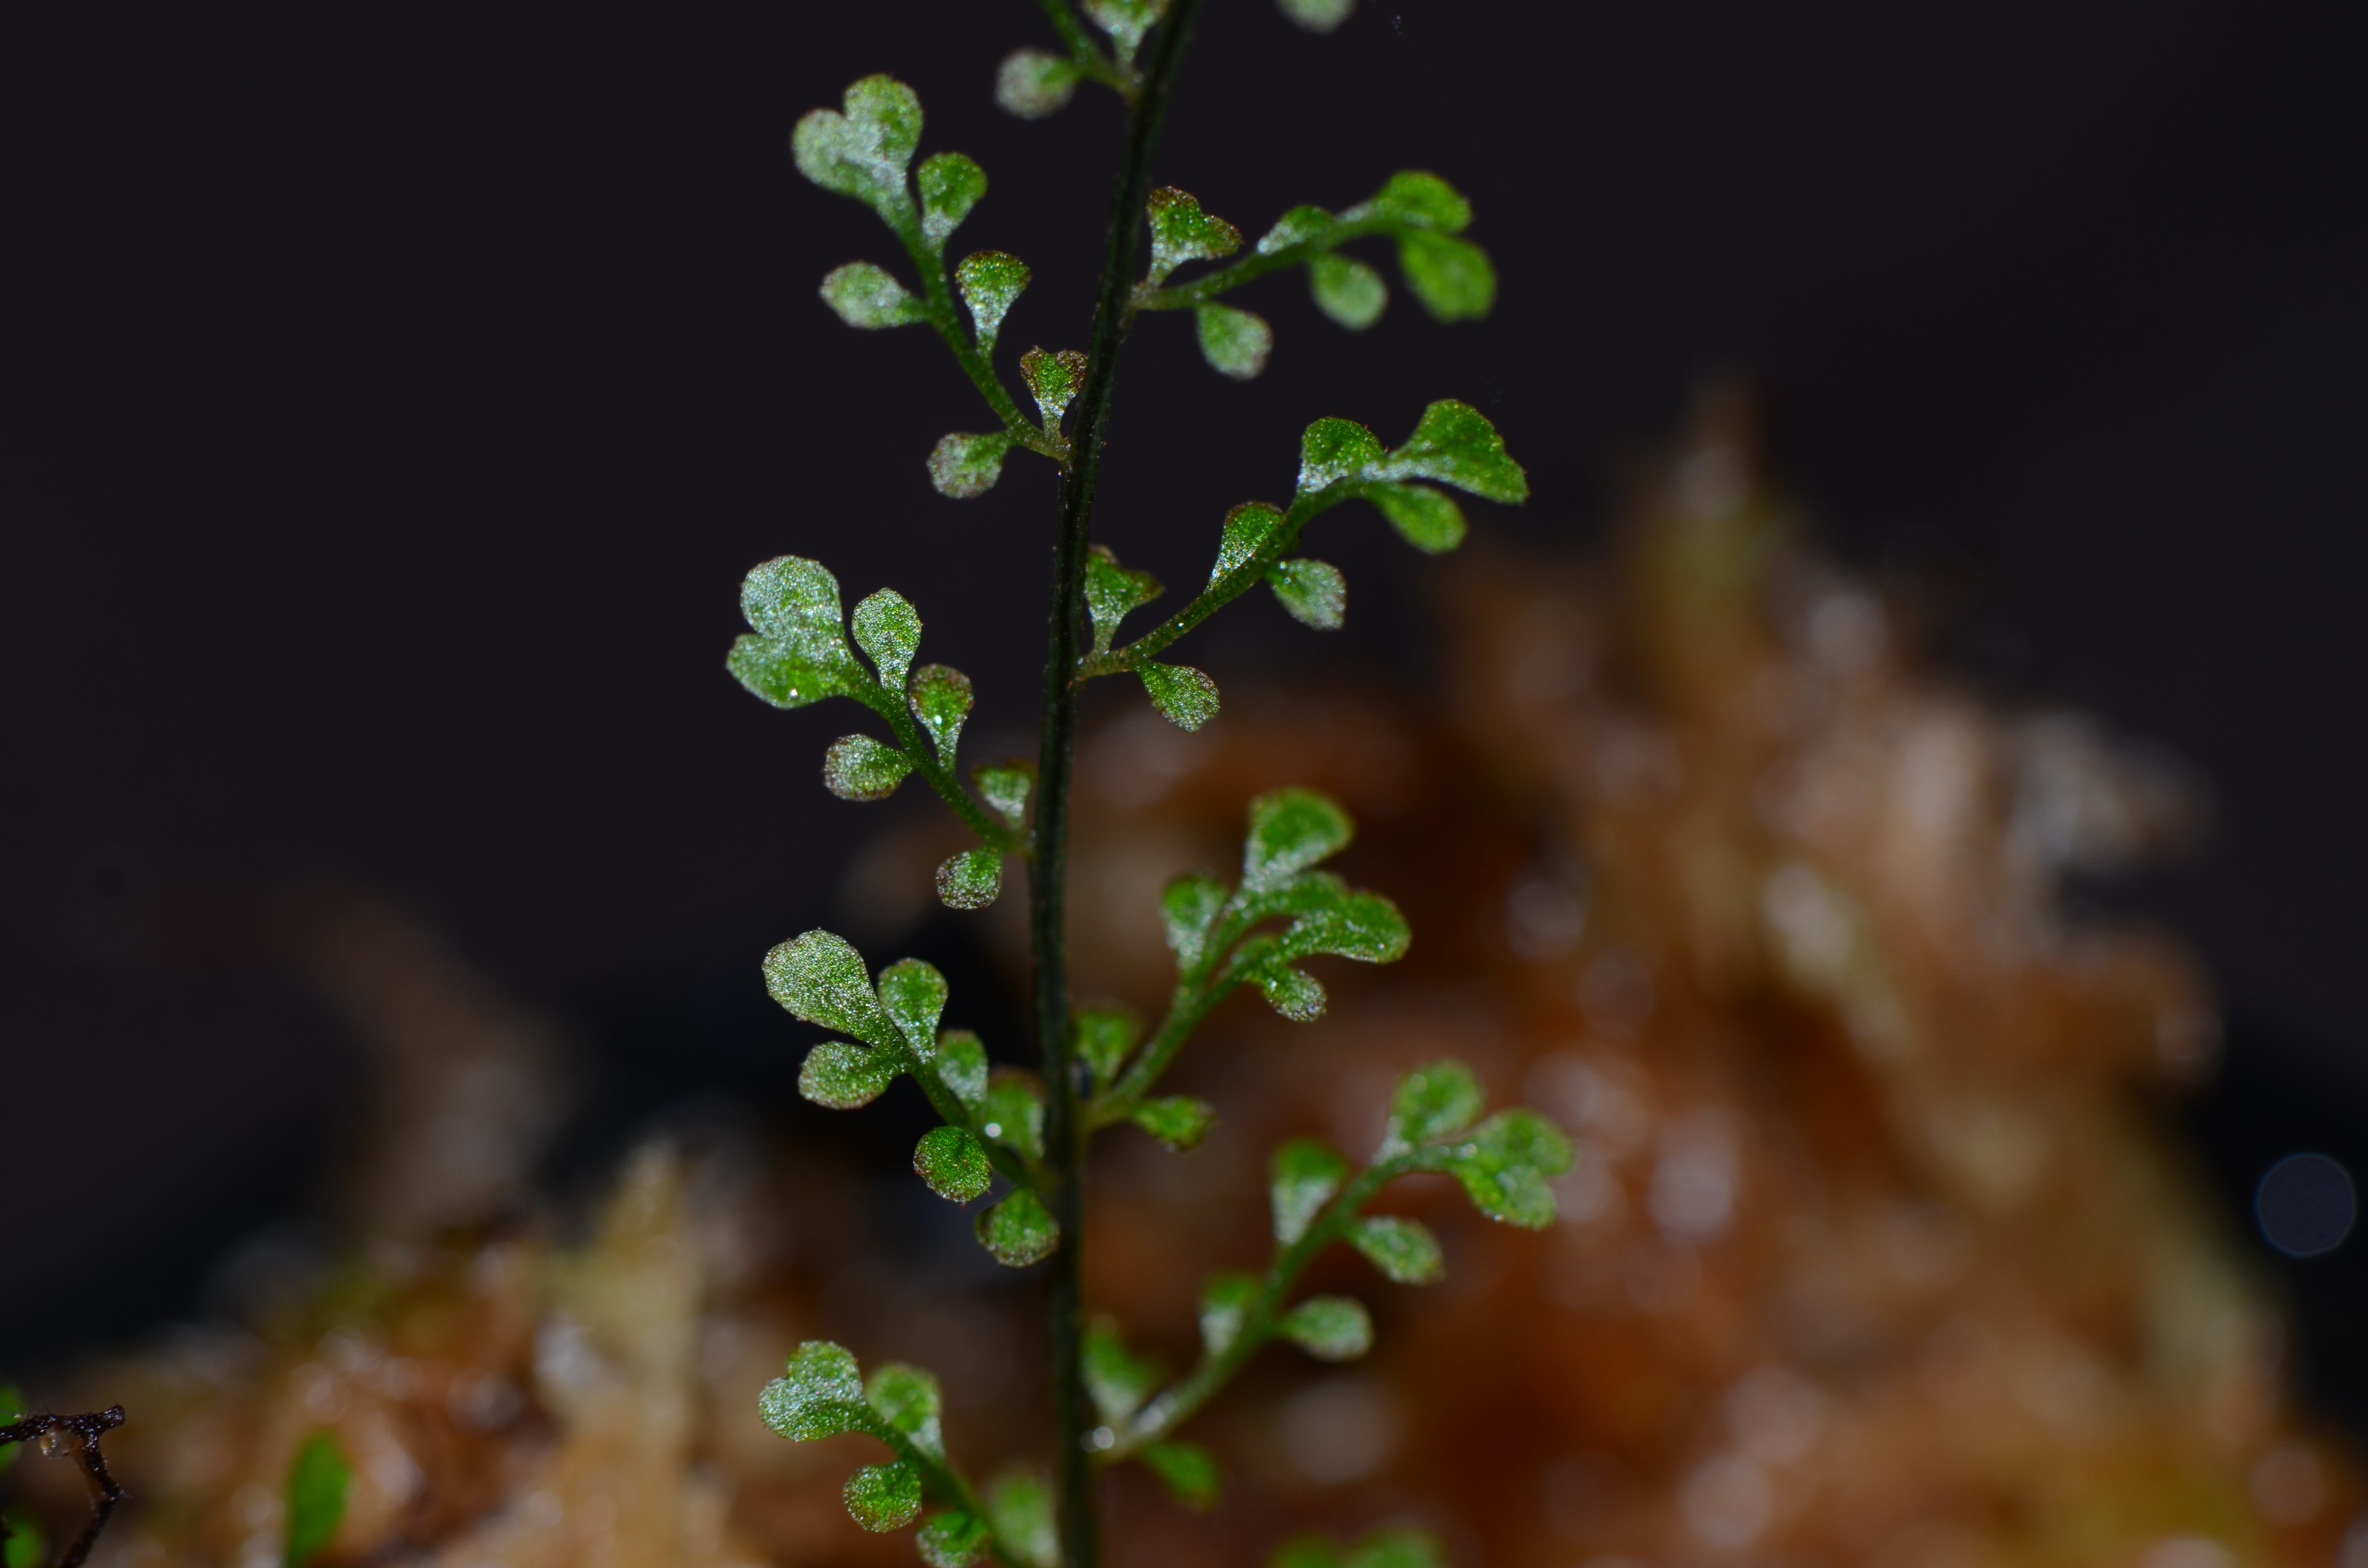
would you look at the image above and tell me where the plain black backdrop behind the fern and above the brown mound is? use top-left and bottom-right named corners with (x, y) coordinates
top-left (0, 0), bottom-right (2368, 1402)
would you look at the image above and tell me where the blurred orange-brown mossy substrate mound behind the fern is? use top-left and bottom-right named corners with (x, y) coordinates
top-left (13, 395), bottom-right (2363, 1568)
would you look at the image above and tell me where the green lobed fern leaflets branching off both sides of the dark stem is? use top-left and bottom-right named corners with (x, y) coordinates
top-left (727, 0), bottom-right (1570, 1568)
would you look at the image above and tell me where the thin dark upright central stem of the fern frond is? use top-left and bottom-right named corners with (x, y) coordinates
top-left (1028, 12), bottom-right (1200, 1568)
